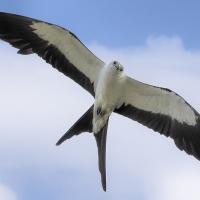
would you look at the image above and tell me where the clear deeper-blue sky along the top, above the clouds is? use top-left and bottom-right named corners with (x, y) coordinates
top-left (0, 0), bottom-right (200, 48)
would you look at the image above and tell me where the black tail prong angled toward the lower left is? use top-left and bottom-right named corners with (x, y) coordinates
top-left (56, 105), bottom-right (94, 145)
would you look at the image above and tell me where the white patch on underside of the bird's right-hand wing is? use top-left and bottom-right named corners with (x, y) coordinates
top-left (125, 77), bottom-right (197, 126)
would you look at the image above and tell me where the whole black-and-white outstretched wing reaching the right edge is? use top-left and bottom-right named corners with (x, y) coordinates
top-left (115, 77), bottom-right (200, 160)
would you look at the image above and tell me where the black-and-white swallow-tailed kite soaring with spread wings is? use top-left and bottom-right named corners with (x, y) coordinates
top-left (0, 12), bottom-right (200, 191)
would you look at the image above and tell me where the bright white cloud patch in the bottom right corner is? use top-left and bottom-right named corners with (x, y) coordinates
top-left (152, 168), bottom-right (200, 200)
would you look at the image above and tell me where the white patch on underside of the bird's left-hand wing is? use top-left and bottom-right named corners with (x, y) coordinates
top-left (31, 22), bottom-right (104, 83)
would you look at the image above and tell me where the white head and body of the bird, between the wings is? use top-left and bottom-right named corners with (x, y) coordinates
top-left (93, 61), bottom-right (125, 133)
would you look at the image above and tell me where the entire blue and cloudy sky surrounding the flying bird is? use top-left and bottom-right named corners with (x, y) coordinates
top-left (0, 0), bottom-right (200, 200)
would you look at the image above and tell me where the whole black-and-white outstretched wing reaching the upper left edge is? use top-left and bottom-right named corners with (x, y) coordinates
top-left (0, 12), bottom-right (104, 96)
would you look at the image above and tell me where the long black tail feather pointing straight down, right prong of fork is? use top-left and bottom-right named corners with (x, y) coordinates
top-left (94, 121), bottom-right (108, 191)
